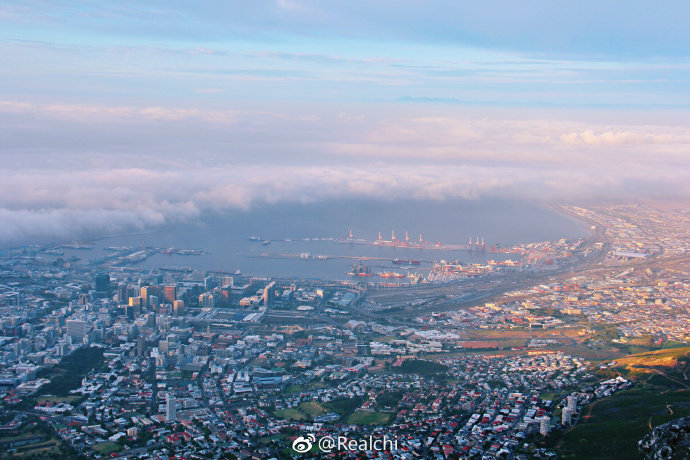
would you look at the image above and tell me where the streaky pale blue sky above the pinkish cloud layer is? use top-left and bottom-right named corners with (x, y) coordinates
top-left (0, 0), bottom-right (690, 108)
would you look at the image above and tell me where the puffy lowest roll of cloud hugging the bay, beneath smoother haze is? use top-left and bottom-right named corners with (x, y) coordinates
top-left (0, 164), bottom-right (690, 245)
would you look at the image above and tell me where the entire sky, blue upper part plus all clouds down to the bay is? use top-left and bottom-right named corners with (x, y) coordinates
top-left (0, 0), bottom-right (690, 244)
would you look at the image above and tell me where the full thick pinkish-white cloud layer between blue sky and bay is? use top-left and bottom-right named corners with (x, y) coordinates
top-left (0, 102), bottom-right (690, 244)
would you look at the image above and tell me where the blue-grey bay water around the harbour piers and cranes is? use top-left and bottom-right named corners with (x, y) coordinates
top-left (55, 199), bottom-right (587, 281)
